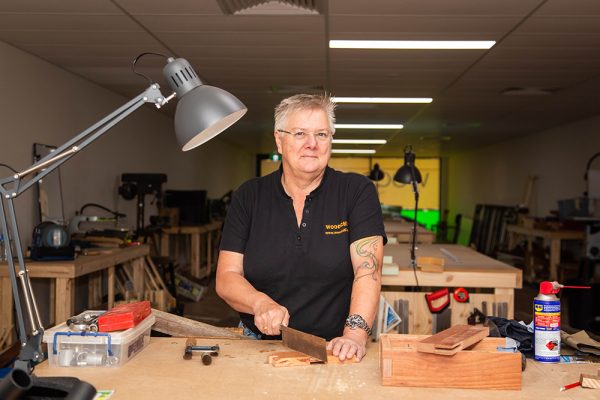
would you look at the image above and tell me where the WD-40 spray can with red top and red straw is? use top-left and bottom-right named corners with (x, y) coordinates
top-left (533, 281), bottom-right (591, 363)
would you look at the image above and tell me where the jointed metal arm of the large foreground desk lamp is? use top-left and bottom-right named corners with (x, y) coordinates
top-left (0, 84), bottom-right (175, 374)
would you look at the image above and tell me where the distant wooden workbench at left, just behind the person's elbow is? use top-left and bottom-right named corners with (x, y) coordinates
top-left (160, 221), bottom-right (223, 279)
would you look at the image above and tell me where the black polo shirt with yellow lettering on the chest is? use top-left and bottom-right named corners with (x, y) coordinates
top-left (220, 167), bottom-right (387, 340)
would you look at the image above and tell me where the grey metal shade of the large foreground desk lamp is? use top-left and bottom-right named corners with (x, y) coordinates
top-left (163, 58), bottom-right (248, 151)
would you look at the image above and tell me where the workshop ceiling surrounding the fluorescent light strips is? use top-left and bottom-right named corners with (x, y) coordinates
top-left (0, 0), bottom-right (600, 157)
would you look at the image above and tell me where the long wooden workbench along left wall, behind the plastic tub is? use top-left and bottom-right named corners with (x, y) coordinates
top-left (0, 245), bottom-right (150, 331)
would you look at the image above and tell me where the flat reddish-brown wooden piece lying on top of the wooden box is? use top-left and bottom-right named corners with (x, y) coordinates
top-left (417, 325), bottom-right (490, 356)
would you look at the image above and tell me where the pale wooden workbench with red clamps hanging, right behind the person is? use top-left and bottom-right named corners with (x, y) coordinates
top-left (381, 243), bottom-right (523, 335)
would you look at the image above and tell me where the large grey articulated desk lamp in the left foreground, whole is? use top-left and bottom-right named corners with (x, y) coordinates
top-left (0, 53), bottom-right (247, 400)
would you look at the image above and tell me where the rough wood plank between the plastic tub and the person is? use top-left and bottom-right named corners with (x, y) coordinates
top-left (152, 309), bottom-right (246, 339)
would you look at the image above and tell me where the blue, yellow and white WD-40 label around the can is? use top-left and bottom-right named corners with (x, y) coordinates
top-left (533, 300), bottom-right (560, 363)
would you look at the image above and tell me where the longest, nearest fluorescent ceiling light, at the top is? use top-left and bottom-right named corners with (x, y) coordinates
top-left (329, 40), bottom-right (496, 50)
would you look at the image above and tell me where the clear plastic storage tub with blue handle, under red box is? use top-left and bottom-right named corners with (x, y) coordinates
top-left (43, 311), bottom-right (155, 367)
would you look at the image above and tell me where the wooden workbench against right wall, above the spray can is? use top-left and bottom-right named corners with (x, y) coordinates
top-left (506, 225), bottom-right (585, 281)
